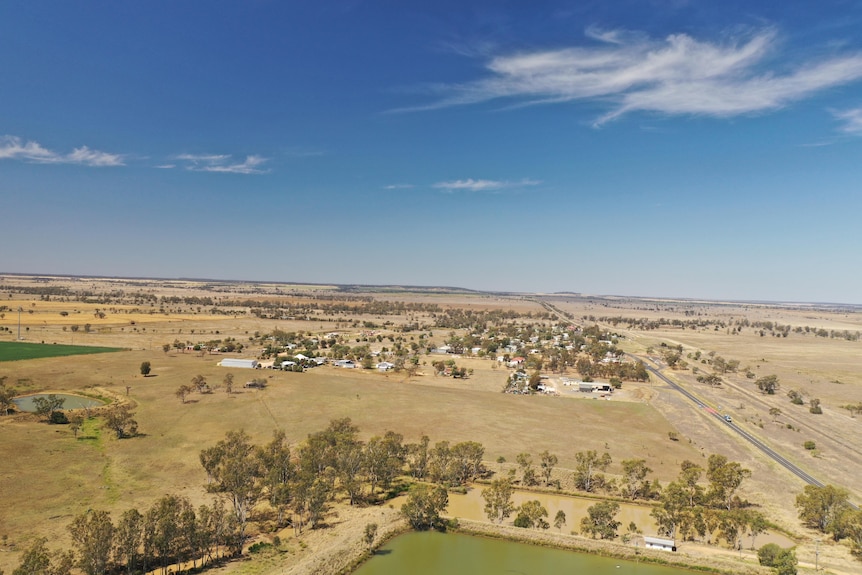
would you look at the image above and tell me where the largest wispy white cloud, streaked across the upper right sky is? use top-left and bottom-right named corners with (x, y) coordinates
top-left (396, 28), bottom-right (862, 125)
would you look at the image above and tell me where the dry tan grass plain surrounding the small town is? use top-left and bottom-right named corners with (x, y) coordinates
top-left (0, 276), bottom-right (862, 572)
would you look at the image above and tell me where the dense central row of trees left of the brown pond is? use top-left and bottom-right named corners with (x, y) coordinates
top-left (200, 424), bottom-right (485, 548)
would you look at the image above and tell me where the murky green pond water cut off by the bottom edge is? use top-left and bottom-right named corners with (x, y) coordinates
top-left (353, 532), bottom-right (692, 575)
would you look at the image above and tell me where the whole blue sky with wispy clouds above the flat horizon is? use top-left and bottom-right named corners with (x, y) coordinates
top-left (0, 0), bottom-right (862, 304)
